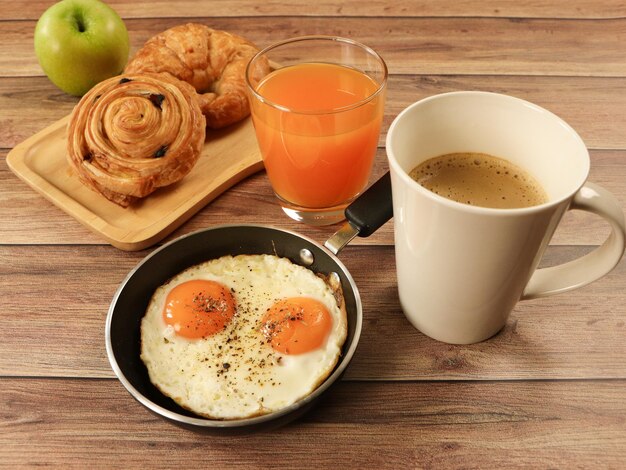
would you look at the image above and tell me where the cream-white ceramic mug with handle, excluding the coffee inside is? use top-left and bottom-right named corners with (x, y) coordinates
top-left (386, 92), bottom-right (625, 344)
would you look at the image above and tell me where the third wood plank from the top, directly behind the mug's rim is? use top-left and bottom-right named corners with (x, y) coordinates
top-left (0, 74), bottom-right (626, 149)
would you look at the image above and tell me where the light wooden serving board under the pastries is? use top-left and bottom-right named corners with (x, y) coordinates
top-left (6, 116), bottom-right (263, 251)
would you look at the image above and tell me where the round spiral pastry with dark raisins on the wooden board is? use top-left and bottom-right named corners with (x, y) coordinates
top-left (67, 74), bottom-right (206, 207)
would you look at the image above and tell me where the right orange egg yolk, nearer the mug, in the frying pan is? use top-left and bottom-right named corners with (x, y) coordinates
top-left (261, 297), bottom-right (332, 354)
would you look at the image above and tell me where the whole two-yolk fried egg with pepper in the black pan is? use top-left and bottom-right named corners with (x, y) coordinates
top-left (141, 255), bottom-right (347, 419)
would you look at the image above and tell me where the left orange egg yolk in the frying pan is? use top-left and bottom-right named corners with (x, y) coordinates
top-left (163, 280), bottom-right (235, 339)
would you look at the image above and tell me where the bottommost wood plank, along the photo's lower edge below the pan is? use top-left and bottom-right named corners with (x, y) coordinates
top-left (0, 379), bottom-right (626, 468)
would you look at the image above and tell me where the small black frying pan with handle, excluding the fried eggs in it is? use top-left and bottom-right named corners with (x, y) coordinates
top-left (105, 173), bottom-right (392, 433)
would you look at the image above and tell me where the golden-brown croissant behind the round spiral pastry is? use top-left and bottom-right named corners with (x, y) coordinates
top-left (126, 23), bottom-right (270, 129)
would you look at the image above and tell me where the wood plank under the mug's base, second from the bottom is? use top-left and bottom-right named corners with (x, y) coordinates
top-left (0, 245), bottom-right (626, 380)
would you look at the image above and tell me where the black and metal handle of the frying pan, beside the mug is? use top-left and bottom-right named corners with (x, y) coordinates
top-left (324, 172), bottom-right (393, 255)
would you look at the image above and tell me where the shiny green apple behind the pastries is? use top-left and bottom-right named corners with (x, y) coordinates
top-left (35, 0), bottom-right (129, 96)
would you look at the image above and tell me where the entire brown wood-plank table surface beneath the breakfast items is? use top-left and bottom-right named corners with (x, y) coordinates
top-left (0, 0), bottom-right (626, 468)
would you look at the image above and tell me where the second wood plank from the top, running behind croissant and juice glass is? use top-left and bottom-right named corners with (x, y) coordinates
top-left (0, 16), bottom-right (626, 77)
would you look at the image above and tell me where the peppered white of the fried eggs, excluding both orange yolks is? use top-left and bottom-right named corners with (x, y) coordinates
top-left (141, 255), bottom-right (347, 419)
